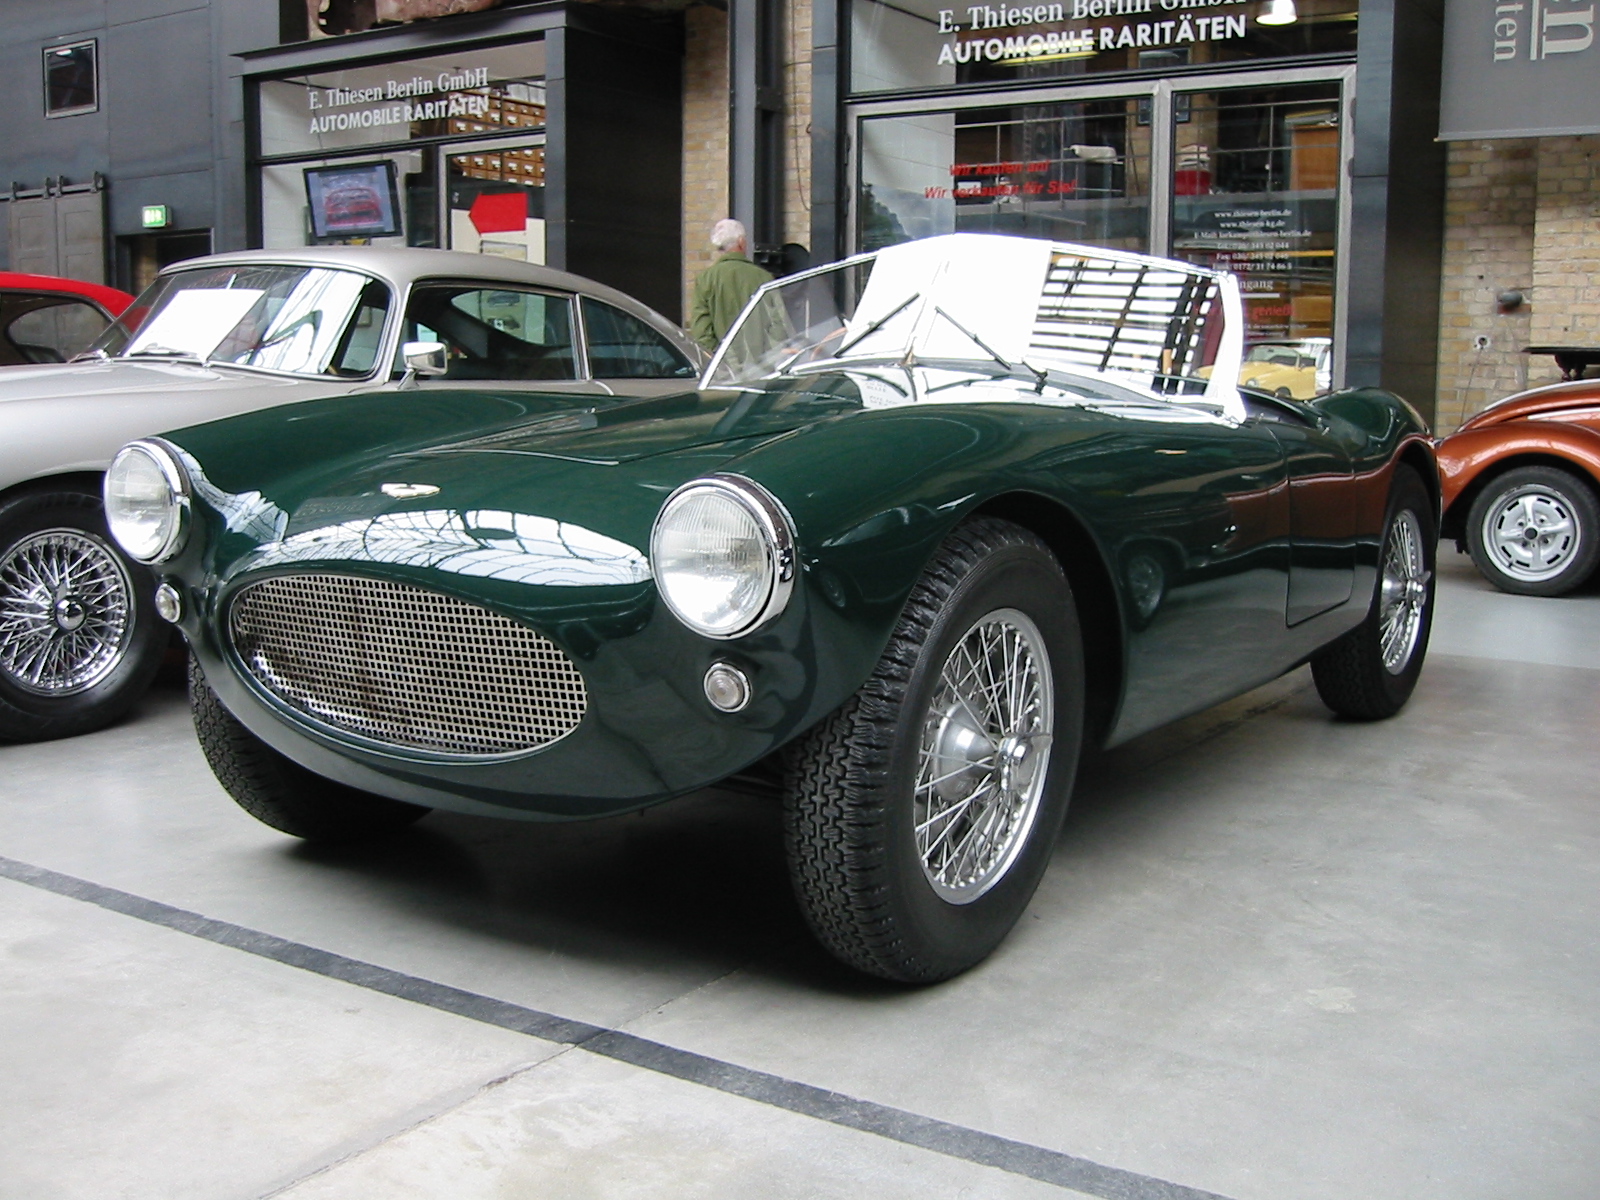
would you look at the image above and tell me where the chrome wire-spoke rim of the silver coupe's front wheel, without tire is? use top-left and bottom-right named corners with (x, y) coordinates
top-left (0, 528), bottom-right (133, 696)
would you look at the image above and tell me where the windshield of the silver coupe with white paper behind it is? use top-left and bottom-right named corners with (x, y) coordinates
top-left (90, 264), bottom-right (389, 378)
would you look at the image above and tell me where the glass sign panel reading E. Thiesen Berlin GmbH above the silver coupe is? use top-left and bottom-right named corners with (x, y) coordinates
top-left (259, 42), bottom-right (546, 158)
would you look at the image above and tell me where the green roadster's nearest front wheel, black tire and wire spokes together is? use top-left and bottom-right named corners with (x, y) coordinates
top-left (784, 518), bottom-right (1083, 982)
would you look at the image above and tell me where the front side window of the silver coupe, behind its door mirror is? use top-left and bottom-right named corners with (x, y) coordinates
top-left (395, 282), bottom-right (608, 395)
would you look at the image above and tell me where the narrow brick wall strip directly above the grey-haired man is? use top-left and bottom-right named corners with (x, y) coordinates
top-left (683, 5), bottom-right (728, 318)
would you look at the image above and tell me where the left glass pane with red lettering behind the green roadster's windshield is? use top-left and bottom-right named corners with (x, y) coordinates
top-left (856, 98), bottom-right (1150, 251)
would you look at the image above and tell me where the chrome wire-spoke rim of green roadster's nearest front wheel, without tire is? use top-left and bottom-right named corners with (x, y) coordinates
top-left (912, 608), bottom-right (1054, 904)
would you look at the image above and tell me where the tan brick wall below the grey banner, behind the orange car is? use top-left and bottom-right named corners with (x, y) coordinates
top-left (1437, 136), bottom-right (1600, 434)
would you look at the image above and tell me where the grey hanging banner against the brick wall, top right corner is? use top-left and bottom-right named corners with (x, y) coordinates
top-left (1438, 0), bottom-right (1600, 141)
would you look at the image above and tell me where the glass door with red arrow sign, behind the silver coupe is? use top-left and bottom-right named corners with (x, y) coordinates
top-left (440, 136), bottom-right (546, 262)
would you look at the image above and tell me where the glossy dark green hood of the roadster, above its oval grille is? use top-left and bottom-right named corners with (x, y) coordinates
top-left (168, 379), bottom-right (861, 592)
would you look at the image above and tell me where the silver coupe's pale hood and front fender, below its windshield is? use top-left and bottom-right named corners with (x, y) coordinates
top-left (0, 358), bottom-right (358, 488)
